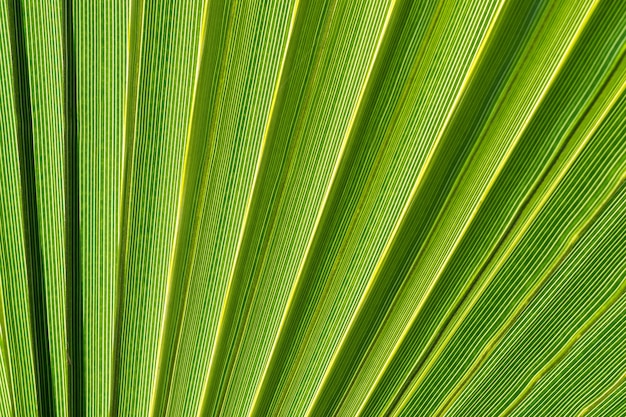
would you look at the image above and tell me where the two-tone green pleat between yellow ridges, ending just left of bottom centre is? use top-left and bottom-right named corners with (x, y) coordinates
top-left (245, 3), bottom-right (508, 415)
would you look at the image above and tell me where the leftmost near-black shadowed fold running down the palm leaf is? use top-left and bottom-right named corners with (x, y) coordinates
top-left (7, 1), bottom-right (64, 415)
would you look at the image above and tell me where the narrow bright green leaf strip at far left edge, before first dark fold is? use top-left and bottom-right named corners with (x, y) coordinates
top-left (0, 2), bottom-right (37, 416)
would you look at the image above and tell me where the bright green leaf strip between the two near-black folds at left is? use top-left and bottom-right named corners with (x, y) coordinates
top-left (22, 0), bottom-right (67, 417)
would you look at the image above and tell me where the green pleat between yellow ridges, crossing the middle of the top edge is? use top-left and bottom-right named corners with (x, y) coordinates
top-left (195, 2), bottom-right (412, 414)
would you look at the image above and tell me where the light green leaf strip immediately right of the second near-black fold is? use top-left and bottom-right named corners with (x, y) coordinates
top-left (72, 0), bottom-right (128, 417)
